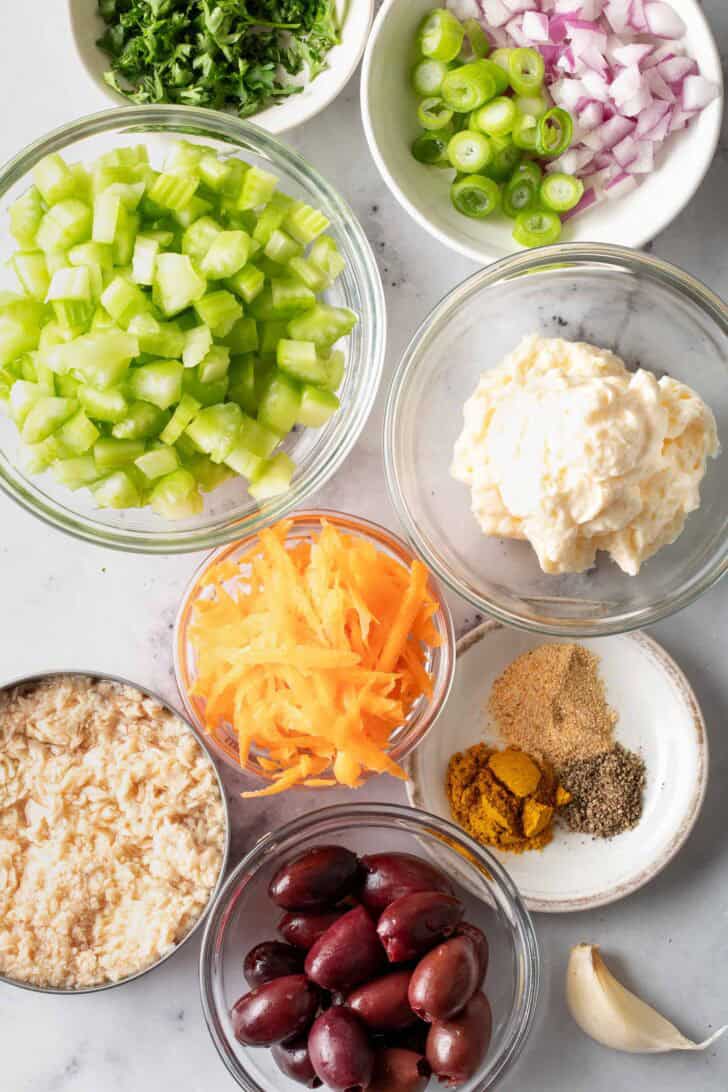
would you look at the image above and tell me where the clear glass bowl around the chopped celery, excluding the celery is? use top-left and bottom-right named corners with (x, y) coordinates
top-left (0, 106), bottom-right (386, 554)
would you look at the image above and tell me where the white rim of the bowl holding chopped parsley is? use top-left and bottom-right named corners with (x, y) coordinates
top-left (67, 0), bottom-right (374, 134)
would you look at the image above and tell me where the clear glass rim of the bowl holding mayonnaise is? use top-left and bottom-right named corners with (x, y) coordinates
top-left (383, 242), bottom-right (728, 639)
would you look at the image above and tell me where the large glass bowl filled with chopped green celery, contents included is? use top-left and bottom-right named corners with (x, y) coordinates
top-left (0, 106), bottom-right (385, 554)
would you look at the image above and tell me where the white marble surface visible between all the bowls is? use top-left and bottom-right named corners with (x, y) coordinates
top-left (0, 0), bottom-right (728, 1092)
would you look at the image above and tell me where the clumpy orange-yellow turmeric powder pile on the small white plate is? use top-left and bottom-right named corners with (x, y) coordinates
top-left (445, 744), bottom-right (571, 853)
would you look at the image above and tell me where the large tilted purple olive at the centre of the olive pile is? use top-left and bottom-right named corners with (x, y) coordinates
top-left (305, 906), bottom-right (386, 993)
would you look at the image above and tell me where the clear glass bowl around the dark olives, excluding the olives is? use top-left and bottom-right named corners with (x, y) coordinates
top-left (200, 804), bottom-right (540, 1092)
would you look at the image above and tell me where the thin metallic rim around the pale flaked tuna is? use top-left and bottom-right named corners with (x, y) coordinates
top-left (0, 667), bottom-right (232, 997)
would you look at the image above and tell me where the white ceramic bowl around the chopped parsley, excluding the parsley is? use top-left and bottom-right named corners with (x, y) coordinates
top-left (68, 0), bottom-right (374, 133)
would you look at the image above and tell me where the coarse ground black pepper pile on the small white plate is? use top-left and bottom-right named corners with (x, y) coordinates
top-left (561, 744), bottom-right (645, 838)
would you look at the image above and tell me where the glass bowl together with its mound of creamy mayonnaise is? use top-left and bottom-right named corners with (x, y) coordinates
top-left (384, 244), bottom-right (728, 637)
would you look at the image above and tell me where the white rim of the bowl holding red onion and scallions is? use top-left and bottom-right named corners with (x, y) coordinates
top-left (360, 0), bottom-right (725, 264)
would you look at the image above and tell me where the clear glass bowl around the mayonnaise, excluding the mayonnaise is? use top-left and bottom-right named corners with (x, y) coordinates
top-left (384, 244), bottom-right (728, 638)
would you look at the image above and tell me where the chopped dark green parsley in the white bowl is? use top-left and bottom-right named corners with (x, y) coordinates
top-left (98, 0), bottom-right (339, 118)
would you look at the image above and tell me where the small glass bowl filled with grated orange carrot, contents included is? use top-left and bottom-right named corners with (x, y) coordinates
top-left (174, 510), bottom-right (455, 796)
